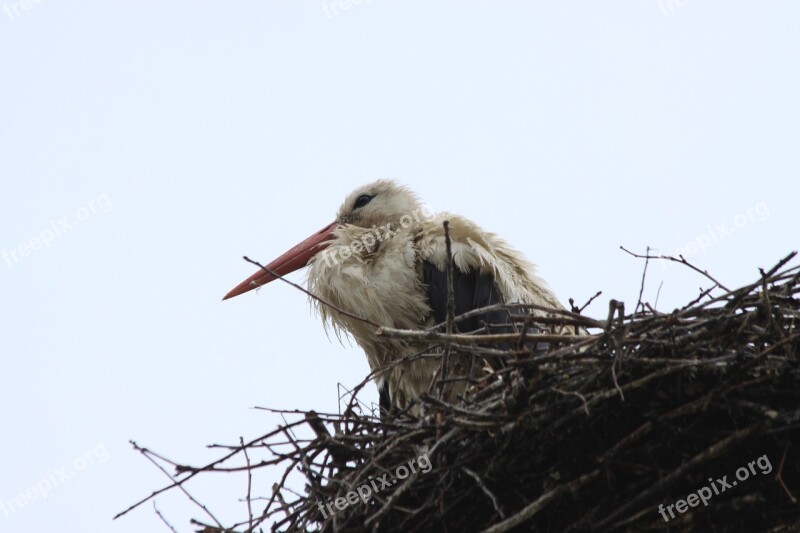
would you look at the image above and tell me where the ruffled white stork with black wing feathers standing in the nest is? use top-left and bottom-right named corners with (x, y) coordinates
top-left (223, 180), bottom-right (563, 409)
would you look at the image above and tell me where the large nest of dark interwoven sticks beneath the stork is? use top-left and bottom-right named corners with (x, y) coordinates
top-left (119, 254), bottom-right (800, 533)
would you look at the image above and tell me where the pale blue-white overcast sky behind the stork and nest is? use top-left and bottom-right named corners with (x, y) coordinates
top-left (0, 0), bottom-right (800, 532)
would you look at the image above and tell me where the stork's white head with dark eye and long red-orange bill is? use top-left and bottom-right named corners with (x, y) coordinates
top-left (223, 180), bottom-right (426, 300)
